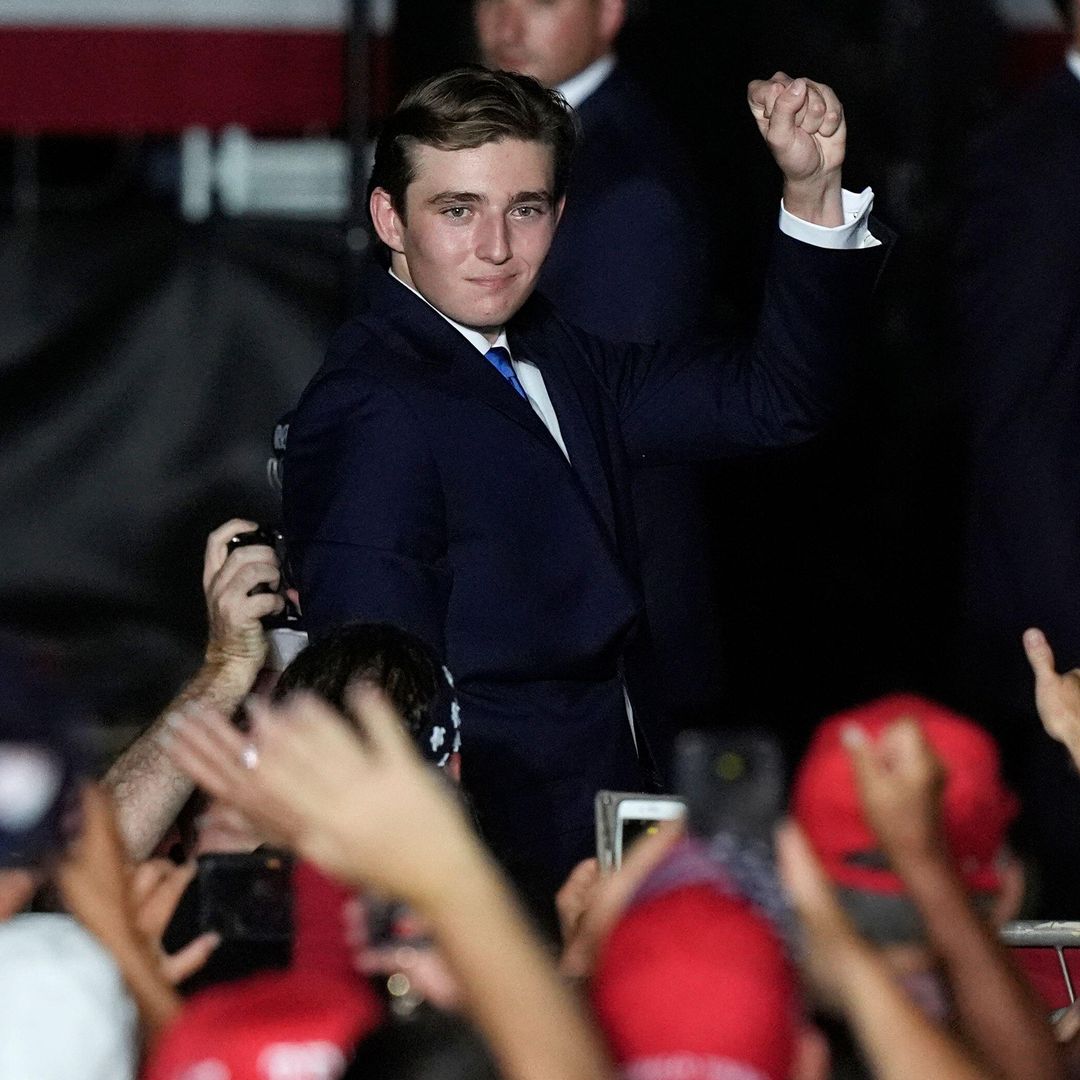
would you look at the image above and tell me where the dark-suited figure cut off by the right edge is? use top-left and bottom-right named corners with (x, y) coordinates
top-left (956, 0), bottom-right (1080, 918)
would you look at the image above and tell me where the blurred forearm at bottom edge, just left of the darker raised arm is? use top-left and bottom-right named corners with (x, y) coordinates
top-left (842, 942), bottom-right (990, 1080)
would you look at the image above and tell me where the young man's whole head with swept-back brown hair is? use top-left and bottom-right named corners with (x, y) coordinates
top-left (368, 68), bottom-right (577, 334)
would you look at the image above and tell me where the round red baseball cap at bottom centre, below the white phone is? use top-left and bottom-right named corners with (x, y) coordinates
top-left (591, 885), bottom-right (801, 1080)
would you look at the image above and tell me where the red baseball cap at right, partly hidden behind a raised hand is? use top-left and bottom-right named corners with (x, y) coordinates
top-left (792, 693), bottom-right (1020, 895)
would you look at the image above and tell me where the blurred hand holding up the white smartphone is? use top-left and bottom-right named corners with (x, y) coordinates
top-left (555, 820), bottom-right (686, 978)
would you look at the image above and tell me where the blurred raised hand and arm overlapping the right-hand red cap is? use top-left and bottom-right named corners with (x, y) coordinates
top-left (845, 719), bottom-right (1064, 1080)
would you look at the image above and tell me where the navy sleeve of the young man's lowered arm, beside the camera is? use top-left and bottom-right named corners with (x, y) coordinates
top-left (283, 366), bottom-right (449, 656)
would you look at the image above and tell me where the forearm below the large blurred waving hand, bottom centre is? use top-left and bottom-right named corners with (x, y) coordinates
top-left (414, 852), bottom-right (610, 1080)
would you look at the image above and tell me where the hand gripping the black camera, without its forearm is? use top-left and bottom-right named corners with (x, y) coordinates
top-left (203, 517), bottom-right (285, 683)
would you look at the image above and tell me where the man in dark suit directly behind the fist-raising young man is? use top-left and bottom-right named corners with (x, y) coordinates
top-left (473, 0), bottom-right (723, 743)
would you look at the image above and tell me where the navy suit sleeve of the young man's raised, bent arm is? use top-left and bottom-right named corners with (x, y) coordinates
top-left (593, 222), bottom-right (889, 464)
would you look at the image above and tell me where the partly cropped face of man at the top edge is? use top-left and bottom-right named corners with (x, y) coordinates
top-left (473, 0), bottom-right (625, 86)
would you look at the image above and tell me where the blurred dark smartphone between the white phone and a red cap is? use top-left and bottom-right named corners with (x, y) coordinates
top-left (674, 729), bottom-right (784, 846)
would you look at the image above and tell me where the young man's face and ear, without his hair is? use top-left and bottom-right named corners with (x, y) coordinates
top-left (370, 139), bottom-right (563, 341)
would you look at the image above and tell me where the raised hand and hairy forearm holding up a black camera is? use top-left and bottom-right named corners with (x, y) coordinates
top-left (105, 518), bottom-right (284, 859)
